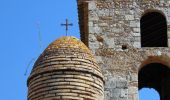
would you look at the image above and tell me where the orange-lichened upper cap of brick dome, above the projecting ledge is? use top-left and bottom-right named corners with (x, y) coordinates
top-left (27, 36), bottom-right (102, 77)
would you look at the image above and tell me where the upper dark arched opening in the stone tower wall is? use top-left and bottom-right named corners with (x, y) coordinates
top-left (140, 12), bottom-right (168, 47)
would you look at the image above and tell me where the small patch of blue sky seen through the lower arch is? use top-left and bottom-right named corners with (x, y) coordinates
top-left (139, 88), bottom-right (160, 100)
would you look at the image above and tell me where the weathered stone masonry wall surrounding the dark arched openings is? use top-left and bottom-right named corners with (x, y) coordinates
top-left (78, 0), bottom-right (170, 100)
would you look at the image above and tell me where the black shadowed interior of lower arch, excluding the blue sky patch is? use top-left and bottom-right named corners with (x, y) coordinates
top-left (138, 63), bottom-right (170, 100)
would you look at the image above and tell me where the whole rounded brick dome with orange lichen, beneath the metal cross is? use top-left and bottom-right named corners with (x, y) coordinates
top-left (27, 37), bottom-right (104, 100)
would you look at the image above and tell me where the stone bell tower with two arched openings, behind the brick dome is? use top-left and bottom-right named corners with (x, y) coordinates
top-left (77, 0), bottom-right (170, 100)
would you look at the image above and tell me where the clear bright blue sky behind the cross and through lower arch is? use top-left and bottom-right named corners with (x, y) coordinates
top-left (0, 0), bottom-right (158, 100)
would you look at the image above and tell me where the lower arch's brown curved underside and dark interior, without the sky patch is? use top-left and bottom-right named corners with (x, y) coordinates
top-left (138, 56), bottom-right (170, 100)
